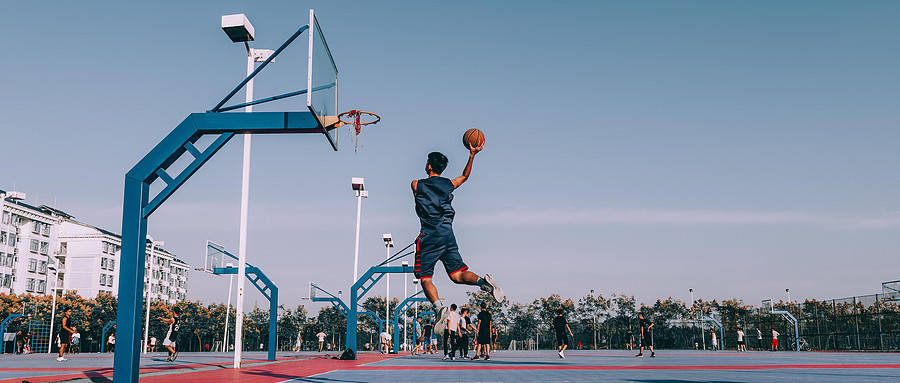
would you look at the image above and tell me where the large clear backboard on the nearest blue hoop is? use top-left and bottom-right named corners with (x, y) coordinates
top-left (306, 9), bottom-right (339, 150)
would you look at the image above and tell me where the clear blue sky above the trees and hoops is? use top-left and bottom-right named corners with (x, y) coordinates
top-left (0, 1), bottom-right (900, 307)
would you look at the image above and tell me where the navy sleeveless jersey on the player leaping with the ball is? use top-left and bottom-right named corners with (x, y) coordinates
top-left (416, 177), bottom-right (456, 235)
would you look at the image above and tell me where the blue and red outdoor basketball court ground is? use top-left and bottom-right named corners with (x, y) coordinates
top-left (0, 350), bottom-right (900, 383)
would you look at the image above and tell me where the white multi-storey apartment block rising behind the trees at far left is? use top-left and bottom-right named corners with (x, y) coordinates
top-left (0, 190), bottom-right (190, 303)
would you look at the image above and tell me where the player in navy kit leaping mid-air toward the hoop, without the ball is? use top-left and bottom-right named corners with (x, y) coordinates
top-left (412, 143), bottom-right (505, 334)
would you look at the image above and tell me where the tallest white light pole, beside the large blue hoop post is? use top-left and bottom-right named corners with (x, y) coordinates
top-left (222, 13), bottom-right (275, 368)
